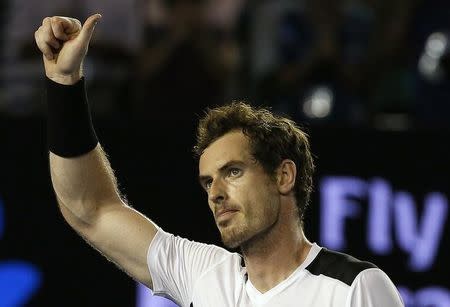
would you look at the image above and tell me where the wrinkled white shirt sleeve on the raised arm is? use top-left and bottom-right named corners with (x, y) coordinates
top-left (147, 228), bottom-right (231, 306)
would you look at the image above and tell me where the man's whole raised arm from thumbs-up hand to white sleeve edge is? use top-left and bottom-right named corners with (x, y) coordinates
top-left (35, 14), bottom-right (157, 287)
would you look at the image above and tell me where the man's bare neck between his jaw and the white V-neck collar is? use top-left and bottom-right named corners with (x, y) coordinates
top-left (241, 217), bottom-right (312, 293)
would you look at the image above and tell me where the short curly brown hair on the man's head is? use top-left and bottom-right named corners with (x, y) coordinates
top-left (194, 101), bottom-right (314, 224)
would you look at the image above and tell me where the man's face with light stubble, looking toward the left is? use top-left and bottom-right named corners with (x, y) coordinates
top-left (199, 131), bottom-right (280, 248)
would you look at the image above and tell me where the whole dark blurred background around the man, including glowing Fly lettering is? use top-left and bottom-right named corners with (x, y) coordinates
top-left (0, 0), bottom-right (450, 307)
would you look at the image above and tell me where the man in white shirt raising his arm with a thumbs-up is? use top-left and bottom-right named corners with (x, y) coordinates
top-left (35, 14), bottom-right (402, 307)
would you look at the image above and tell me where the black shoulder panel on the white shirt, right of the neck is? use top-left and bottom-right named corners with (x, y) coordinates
top-left (306, 248), bottom-right (377, 286)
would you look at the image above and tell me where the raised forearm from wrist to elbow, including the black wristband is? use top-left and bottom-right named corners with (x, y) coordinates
top-left (47, 76), bottom-right (121, 230)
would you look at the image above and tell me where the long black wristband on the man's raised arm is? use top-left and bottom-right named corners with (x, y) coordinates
top-left (46, 78), bottom-right (98, 158)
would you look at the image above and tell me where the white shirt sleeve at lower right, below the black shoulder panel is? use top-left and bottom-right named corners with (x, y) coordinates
top-left (346, 268), bottom-right (404, 307)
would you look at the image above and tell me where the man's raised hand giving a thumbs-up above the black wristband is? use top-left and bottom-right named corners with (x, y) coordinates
top-left (34, 14), bottom-right (102, 85)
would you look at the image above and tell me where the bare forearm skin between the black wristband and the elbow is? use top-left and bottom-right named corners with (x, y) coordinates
top-left (49, 145), bottom-right (121, 225)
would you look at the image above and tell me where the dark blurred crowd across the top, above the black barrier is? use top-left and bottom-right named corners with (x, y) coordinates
top-left (0, 0), bottom-right (450, 130)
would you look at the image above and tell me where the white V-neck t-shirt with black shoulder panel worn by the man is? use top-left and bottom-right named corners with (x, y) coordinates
top-left (147, 229), bottom-right (403, 307)
